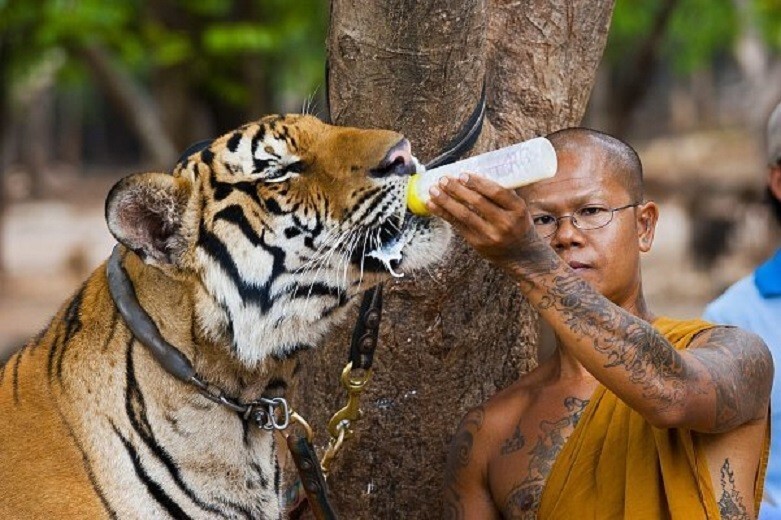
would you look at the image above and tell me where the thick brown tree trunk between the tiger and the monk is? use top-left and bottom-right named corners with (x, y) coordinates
top-left (294, 0), bottom-right (613, 519)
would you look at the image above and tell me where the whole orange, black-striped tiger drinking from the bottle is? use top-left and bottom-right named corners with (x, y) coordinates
top-left (0, 114), bottom-right (451, 519)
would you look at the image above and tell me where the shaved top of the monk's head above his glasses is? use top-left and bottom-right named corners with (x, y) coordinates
top-left (547, 128), bottom-right (643, 202)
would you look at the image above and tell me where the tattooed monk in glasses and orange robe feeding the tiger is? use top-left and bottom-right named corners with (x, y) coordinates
top-left (429, 128), bottom-right (773, 520)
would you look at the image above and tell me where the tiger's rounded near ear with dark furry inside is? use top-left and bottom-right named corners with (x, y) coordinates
top-left (106, 173), bottom-right (190, 264)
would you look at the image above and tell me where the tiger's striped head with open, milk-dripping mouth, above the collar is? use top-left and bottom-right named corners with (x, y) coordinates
top-left (106, 115), bottom-right (450, 366)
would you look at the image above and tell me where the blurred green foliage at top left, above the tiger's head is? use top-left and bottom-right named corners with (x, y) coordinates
top-left (0, 0), bottom-right (328, 108)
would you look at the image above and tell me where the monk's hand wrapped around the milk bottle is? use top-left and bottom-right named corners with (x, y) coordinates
top-left (428, 174), bottom-right (539, 267)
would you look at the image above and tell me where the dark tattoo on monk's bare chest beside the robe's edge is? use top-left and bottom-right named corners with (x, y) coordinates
top-left (502, 396), bottom-right (588, 519)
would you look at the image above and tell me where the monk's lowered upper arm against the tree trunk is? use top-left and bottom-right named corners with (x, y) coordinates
top-left (442, 407), bottom-right (499, 520)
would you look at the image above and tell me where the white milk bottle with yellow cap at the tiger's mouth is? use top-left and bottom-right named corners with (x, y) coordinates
top-left (407, 137), bottom-right (557, 216)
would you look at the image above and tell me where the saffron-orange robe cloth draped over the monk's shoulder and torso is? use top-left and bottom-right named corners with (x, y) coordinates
top-left (538, 318), bottom-right (768, 520)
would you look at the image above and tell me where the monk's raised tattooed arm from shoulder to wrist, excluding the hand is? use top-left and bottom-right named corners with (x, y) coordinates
top-left (511, 238), bottom-right (773, 432)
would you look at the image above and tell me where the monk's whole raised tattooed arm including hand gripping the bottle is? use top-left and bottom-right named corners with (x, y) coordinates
top-left (430, 176), bottom-right (773, 432)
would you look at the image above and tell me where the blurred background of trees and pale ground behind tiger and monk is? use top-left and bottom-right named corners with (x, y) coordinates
top-left (0, 0), bottom-right (781, 361)
